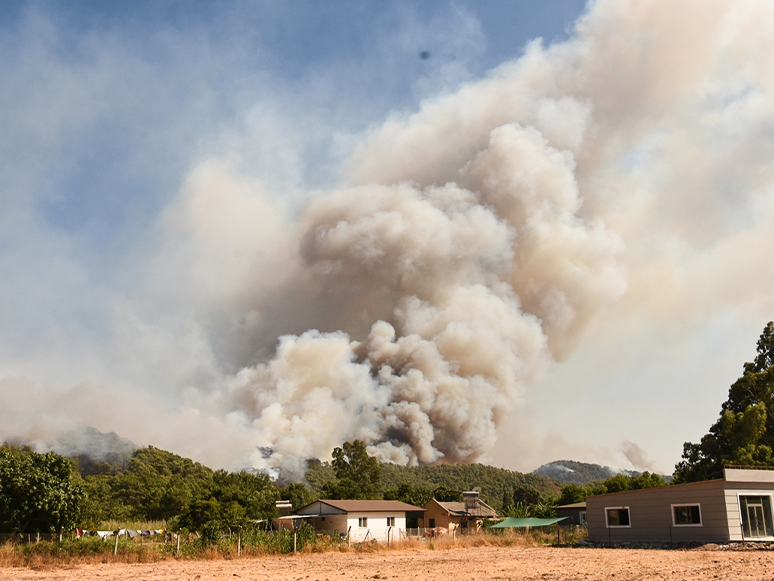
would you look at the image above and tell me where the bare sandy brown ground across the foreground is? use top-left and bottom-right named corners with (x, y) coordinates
top-left (0, 547), bottom-right (774, 581)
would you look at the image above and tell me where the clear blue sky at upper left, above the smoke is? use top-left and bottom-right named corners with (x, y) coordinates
top-left (0, 2), bottom-right (583, 268)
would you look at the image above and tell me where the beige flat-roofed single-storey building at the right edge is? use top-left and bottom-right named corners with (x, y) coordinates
top-left (586, 466), bottom-right (774, 544)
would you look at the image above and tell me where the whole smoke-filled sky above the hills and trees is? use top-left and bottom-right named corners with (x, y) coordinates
top-left (0, 0), bottom-right (774, 472)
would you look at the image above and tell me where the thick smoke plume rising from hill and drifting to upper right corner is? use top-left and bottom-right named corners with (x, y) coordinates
top-left (218, 0), bottom-right (772, 476)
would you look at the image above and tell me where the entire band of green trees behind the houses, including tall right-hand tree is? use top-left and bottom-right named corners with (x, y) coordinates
top-left (0, 322), bottom-right (774, 532)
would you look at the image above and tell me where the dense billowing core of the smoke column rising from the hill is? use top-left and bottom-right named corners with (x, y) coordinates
top-left (231, 121), bottom-right (625, 469)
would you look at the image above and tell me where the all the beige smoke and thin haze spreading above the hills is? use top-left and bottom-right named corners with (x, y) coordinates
top-left (0, 0), bottom-right (774, 474)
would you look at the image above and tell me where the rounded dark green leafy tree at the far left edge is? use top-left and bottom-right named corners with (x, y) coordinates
top-left (0, 446), bottom-right (86, 533)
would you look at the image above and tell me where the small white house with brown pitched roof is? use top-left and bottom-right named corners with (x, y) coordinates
top-left (296, 500), bottom-right (424, 543)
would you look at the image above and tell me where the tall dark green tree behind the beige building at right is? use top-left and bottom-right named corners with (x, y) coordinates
top-left (674, 322), bottom-right (774, 483)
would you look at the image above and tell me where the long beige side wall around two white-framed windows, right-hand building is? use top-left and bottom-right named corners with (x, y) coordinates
top-left (586, 480), bottom-right (739, 544)
